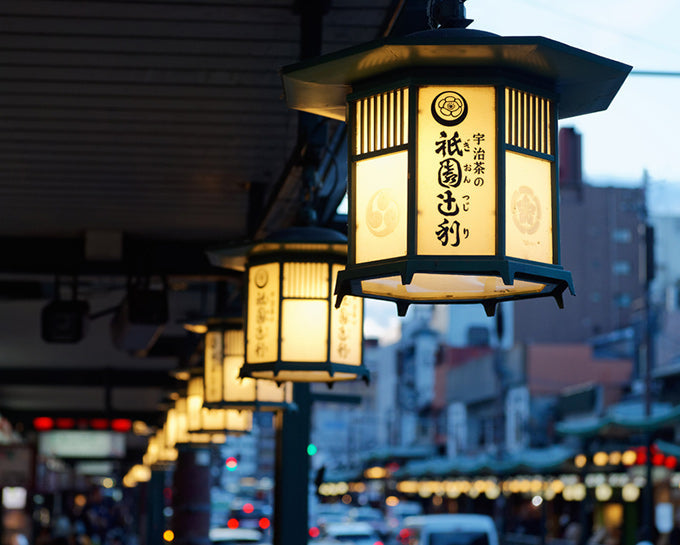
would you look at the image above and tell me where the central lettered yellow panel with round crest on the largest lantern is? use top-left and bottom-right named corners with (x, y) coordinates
top-left (416, 86), bottom-right (496, 255)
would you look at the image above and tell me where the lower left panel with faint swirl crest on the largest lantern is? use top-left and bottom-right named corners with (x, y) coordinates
top-left (353, 151), bottom-right (408, 263)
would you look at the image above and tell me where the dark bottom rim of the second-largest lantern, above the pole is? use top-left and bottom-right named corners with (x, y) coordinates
top-left (241, 362), bottom-right (369, 384)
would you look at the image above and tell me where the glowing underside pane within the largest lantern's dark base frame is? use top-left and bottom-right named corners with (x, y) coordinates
top-left (361, 273), bottom-right (546, 301)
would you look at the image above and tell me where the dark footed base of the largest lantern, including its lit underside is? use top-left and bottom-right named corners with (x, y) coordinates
top-left (335, 257), bottom-right (574, 316)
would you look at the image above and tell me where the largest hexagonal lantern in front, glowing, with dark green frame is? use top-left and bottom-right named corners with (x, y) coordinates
top-left (282, 9), bottom-right (631, 315)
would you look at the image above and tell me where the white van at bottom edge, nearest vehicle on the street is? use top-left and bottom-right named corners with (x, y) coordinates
top-left (397, 513), bottom-right (498, 545)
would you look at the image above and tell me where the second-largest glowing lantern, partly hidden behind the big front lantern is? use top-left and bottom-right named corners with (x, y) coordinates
top-left (209, 227), bottom-right (368, 383)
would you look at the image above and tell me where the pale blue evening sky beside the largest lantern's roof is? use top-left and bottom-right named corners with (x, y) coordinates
top-left (472, 0), bottom-right (680, 186)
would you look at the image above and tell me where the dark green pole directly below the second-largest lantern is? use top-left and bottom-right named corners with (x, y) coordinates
top-left (273, 383), bottom-right (312, 545)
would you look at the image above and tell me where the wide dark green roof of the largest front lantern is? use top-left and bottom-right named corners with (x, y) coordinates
top-left (281, 28), bottom-right (632, 121)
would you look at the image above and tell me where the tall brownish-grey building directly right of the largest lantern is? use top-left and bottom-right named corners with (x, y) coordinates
top-left (514, 129), bottom-right (645, 343)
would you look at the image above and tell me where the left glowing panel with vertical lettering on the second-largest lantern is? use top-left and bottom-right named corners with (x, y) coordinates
top-left (246, 263), bottom-right (279, 363)
